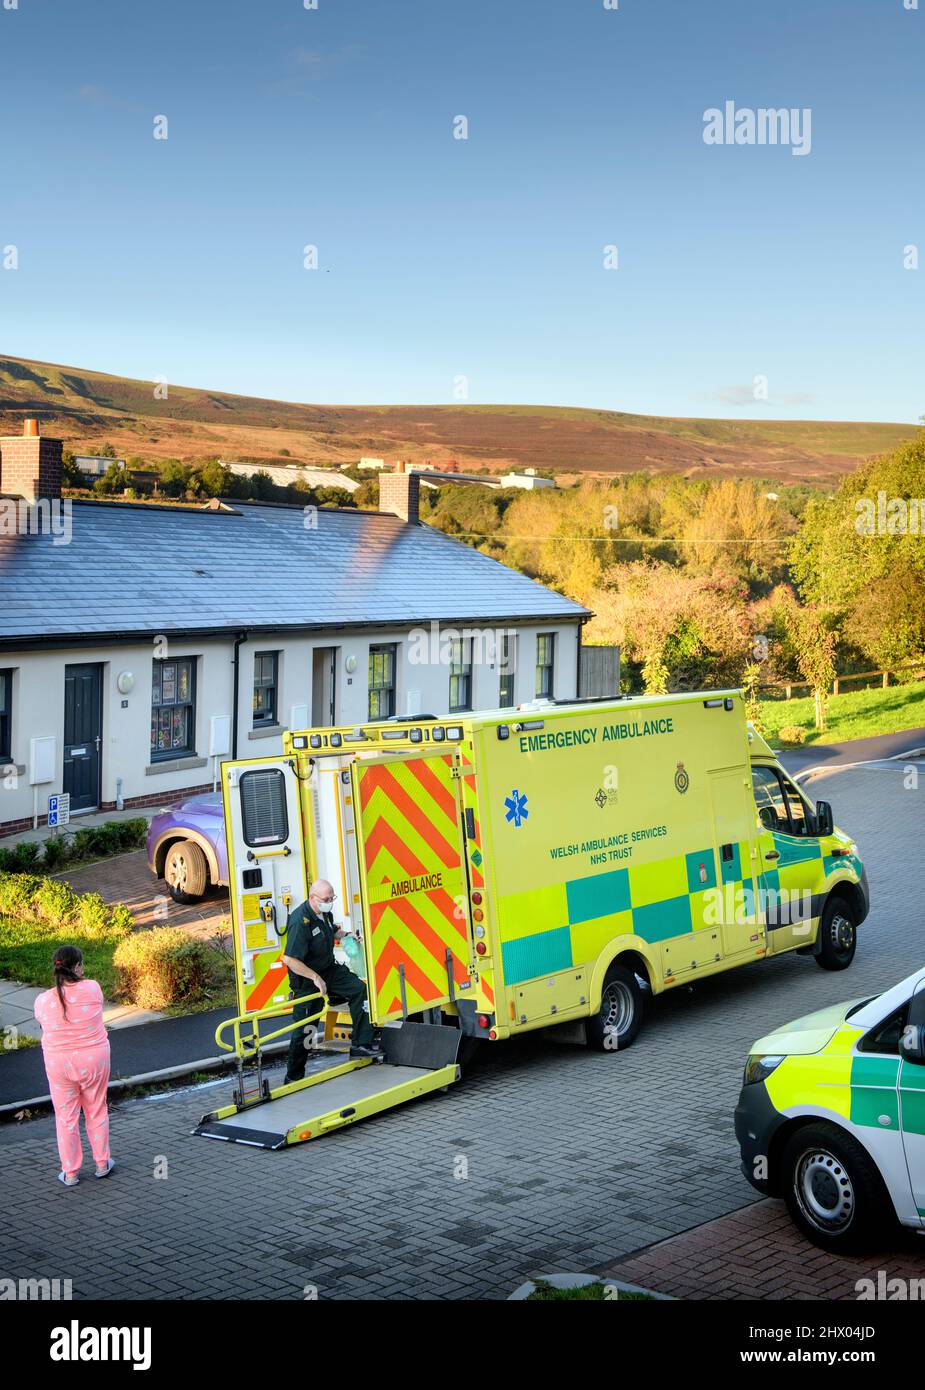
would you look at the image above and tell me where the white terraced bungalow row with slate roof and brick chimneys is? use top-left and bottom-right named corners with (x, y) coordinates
top-left (0, 421), bottom-right (590, 835)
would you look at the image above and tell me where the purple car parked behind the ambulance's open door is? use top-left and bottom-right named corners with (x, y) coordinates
top-left (147, 792), bottom-right (228, 902)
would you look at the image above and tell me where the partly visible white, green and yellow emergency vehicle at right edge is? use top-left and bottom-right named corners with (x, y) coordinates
top-left (736, 970), bottom-right (925, 1251)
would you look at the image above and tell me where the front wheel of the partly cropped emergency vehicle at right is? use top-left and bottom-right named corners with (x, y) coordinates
top-left (783, 1123), bottom-right (896, 1251)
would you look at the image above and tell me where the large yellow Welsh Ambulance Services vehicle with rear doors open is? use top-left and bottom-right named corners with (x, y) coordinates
top-left (198, 691), bottom-right (868, 1147)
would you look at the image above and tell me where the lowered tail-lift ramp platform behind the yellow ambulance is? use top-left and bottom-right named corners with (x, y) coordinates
top-left (193, 1023), bottom-right (460, 1150)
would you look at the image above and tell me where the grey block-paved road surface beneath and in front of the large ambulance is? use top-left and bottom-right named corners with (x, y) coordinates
top-left (0, 766), bottom-right (925, 1298)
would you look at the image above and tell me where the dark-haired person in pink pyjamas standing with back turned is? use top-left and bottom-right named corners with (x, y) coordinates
top-left (35, 947), bottom-right (113, 1187)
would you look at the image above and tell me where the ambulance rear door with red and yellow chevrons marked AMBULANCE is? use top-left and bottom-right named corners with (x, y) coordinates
top-left (352, 752), bottom-right (472, 1023)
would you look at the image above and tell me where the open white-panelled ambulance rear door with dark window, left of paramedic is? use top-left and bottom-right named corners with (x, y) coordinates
top-left (221, 758), bottom-right (307, 1013)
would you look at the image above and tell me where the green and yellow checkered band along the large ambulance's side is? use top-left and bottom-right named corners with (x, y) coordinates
top-left (499, 841), bottom-right (755, 986)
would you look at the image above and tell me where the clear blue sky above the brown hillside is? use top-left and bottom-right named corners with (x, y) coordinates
top-left (0, 0), bottom-right (925, 421)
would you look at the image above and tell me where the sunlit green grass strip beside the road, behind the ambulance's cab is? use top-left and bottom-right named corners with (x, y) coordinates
top-left (761, 681), bottom-right (925, 746)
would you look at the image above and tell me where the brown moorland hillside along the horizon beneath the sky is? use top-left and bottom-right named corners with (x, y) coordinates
top-left (0, 357), bottom-right (917, 482)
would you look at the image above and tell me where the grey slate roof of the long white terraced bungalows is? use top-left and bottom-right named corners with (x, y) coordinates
top-left (0, 500), bottom-right (587, 646)
